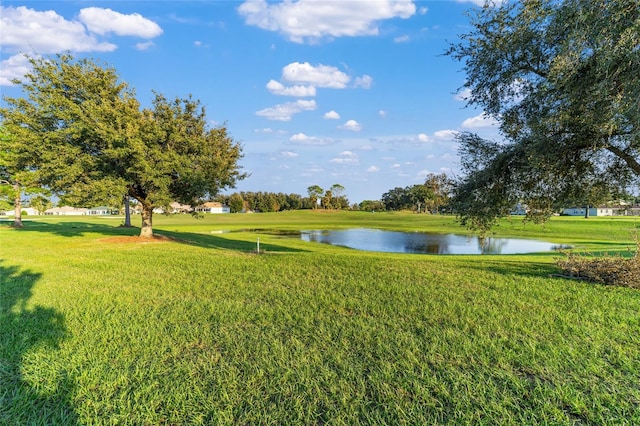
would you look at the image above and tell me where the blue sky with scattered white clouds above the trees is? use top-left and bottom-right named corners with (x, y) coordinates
top-left (0, 0), bottom-right (497, 202)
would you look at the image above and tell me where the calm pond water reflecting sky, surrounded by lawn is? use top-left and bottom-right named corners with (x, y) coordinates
top-left (301, 229), bottom-right (560, 254)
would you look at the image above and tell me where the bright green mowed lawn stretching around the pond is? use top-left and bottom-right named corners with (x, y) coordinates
top-left (0, 212), bottom-right (640, 425)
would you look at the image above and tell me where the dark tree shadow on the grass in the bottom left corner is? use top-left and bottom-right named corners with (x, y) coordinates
top-left (0, 264), bottom-right (79, 425)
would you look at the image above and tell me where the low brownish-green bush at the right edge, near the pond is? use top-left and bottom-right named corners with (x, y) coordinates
top-left (556, 237), bottom-right (640, 289)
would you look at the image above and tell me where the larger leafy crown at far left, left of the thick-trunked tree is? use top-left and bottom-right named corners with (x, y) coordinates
top-left (0, 54), bottom-right (132, 220)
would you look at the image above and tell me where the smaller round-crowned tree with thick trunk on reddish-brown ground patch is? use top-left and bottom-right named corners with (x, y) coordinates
top-left (127, 94), bottom-right (245, 236)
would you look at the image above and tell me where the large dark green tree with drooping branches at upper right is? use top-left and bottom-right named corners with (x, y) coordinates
top-left (448, 0), bottom-right (640, 231)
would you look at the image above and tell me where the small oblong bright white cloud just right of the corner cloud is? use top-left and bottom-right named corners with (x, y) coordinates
top-left (78, 7), bottom-right (162, 38)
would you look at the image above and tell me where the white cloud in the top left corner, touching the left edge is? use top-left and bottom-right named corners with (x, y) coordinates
top-left (0, 6), bottom-right (117, 54)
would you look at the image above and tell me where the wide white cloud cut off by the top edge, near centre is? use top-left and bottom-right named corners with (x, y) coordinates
top-left (238, 0), bottom-right (416, 43)
